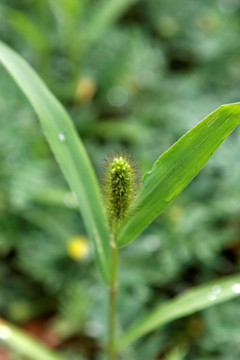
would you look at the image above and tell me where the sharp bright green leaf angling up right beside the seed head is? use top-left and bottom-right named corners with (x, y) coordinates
top-left (117, 103), bottom-right (240, 247)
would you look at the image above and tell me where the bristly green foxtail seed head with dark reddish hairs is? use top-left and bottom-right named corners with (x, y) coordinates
top-left (104, 154), bottom-right (137, 224)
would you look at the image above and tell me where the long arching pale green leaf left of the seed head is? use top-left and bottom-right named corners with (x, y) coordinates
top-left (0, 42), bottom-right (110, 283)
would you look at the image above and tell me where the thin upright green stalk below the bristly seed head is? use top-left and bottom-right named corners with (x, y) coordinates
top-left (107, 232), bottom-right (118, 360)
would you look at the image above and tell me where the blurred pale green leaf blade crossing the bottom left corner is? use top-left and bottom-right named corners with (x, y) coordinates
top-left (0, 318), bottom-right (66, 360)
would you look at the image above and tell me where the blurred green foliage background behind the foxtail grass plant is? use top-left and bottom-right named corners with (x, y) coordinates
top-left (0, 0), bottom-right (240, 360)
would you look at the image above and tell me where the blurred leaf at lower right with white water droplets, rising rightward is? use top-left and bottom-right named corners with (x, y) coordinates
top-left (117, 275), bottom-right (240, 350)
